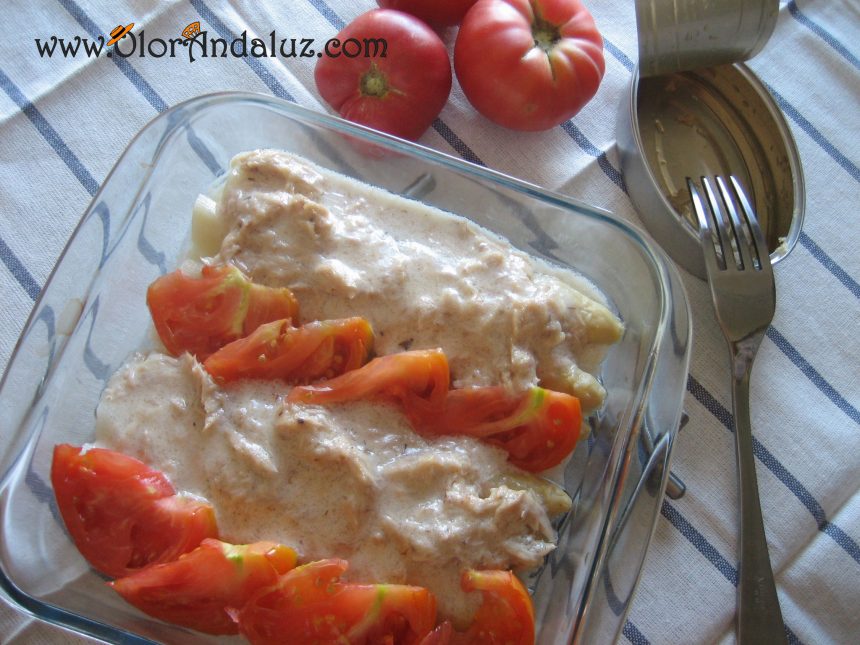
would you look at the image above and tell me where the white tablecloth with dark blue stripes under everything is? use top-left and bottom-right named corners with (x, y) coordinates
top-left (0, 0), bottom-right (860, 645)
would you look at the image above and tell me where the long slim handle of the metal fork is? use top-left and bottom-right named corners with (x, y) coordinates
top-left (732, 347), bottom-right (787, 645)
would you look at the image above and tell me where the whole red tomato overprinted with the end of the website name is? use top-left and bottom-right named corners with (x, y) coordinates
top-left (314, 9), bottom-right (451, 140)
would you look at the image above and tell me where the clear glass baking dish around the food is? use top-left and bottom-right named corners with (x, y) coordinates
top-left (0, 93), bottom-right (691, 645)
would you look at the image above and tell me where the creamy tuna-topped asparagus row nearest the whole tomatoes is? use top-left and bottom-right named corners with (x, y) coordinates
top-left (212, 150), bottom-right (622, 410)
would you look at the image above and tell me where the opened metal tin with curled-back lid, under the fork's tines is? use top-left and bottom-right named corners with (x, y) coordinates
top-left (617, 0), bottom-right (805, 279)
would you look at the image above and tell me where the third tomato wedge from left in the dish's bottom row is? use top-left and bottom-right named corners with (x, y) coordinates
top-left (235, 559), bottom-right (436, 645)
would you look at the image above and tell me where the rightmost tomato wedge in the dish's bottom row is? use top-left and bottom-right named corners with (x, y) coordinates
top-left (451, 569), bottom-right (535, 645)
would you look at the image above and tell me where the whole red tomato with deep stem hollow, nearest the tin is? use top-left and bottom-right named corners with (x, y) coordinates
top-left (454, 0), bottom-right (604, 130)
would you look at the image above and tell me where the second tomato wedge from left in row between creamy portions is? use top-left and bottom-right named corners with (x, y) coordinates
top-left (203, 318), bottom-right (373, 383)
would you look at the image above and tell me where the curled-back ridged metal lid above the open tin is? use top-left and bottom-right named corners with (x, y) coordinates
top-left (636, 0), bottom-right (779, 76)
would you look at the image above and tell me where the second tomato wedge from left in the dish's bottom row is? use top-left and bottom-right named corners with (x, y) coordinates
top-left (110, 539), bottom-right (296, 634)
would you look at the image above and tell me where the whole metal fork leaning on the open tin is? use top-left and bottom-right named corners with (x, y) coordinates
top-left (687, 177), bottom-right (786, 644)
